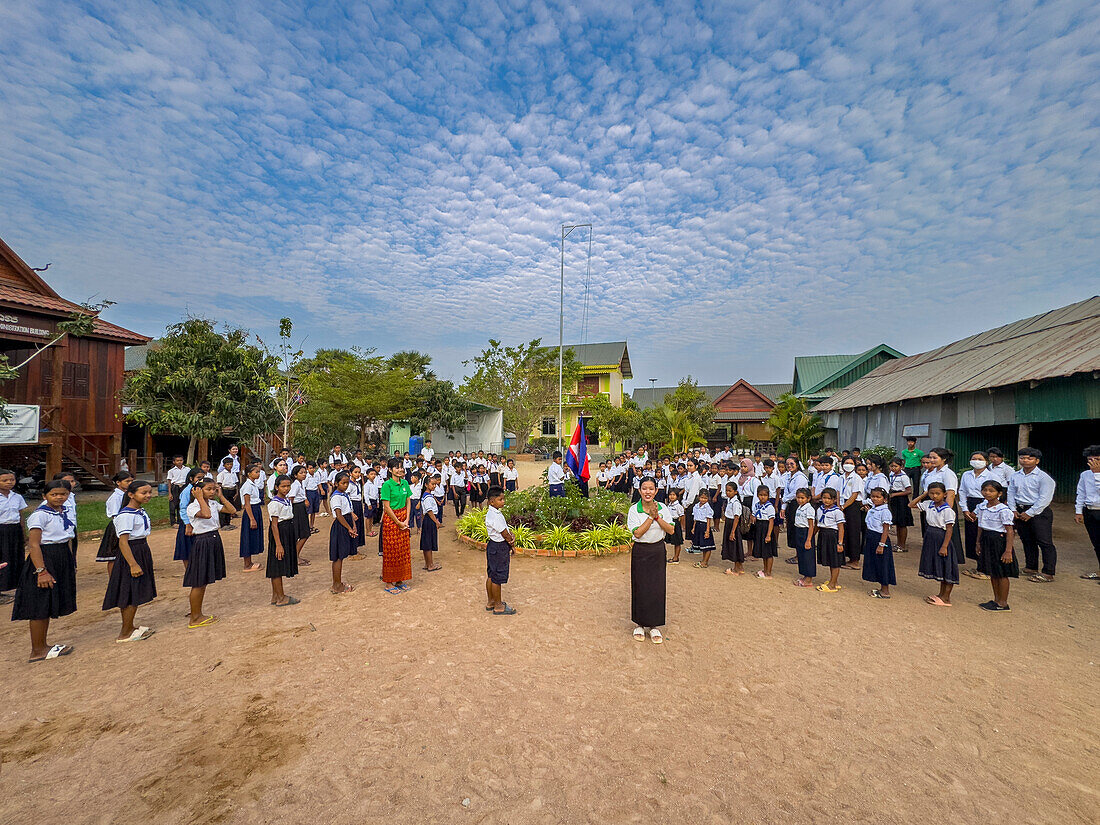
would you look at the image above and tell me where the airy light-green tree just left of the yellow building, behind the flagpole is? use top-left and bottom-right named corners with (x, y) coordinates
top-left (462, 338), bottom-right (581, 450)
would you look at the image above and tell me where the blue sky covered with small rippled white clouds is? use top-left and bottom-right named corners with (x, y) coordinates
top-left (0, 0), bottom-right (1100, 386)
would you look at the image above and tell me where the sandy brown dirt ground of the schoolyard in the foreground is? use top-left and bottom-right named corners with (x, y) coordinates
top-left (0, 464), bottom-right (1100, 825)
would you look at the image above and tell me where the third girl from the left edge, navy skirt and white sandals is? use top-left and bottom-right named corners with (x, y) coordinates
top-left (103, 481), bottom-right (156, 642)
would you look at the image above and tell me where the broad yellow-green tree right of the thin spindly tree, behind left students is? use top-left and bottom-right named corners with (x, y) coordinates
top-left (298, 348), bottom-right (417, 450)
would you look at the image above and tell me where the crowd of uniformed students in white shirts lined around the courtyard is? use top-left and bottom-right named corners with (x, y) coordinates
top-left (0, 441), bottom-right (1100, 661)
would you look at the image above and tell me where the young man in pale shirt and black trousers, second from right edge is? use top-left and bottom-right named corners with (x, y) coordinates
top-left (1008, 447), bottom-right (1058, 582)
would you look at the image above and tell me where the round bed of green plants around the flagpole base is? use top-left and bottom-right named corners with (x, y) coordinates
top-left (455, 484), bottom-right (633, 558)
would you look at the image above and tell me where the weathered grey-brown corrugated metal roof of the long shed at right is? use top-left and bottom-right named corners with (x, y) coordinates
top-left (815, 296), bottom-right (1100, 413)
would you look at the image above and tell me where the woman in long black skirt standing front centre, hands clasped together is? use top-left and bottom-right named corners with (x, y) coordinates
top-left (626, 476), bottom-right (675, 645)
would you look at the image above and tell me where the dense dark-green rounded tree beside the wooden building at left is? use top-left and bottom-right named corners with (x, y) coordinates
top-left (121, 318), bottom-right (281, 463)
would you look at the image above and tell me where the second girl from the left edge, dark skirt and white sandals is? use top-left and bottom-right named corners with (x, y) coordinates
top-left (11, 481), bottom-right (76, 662)
